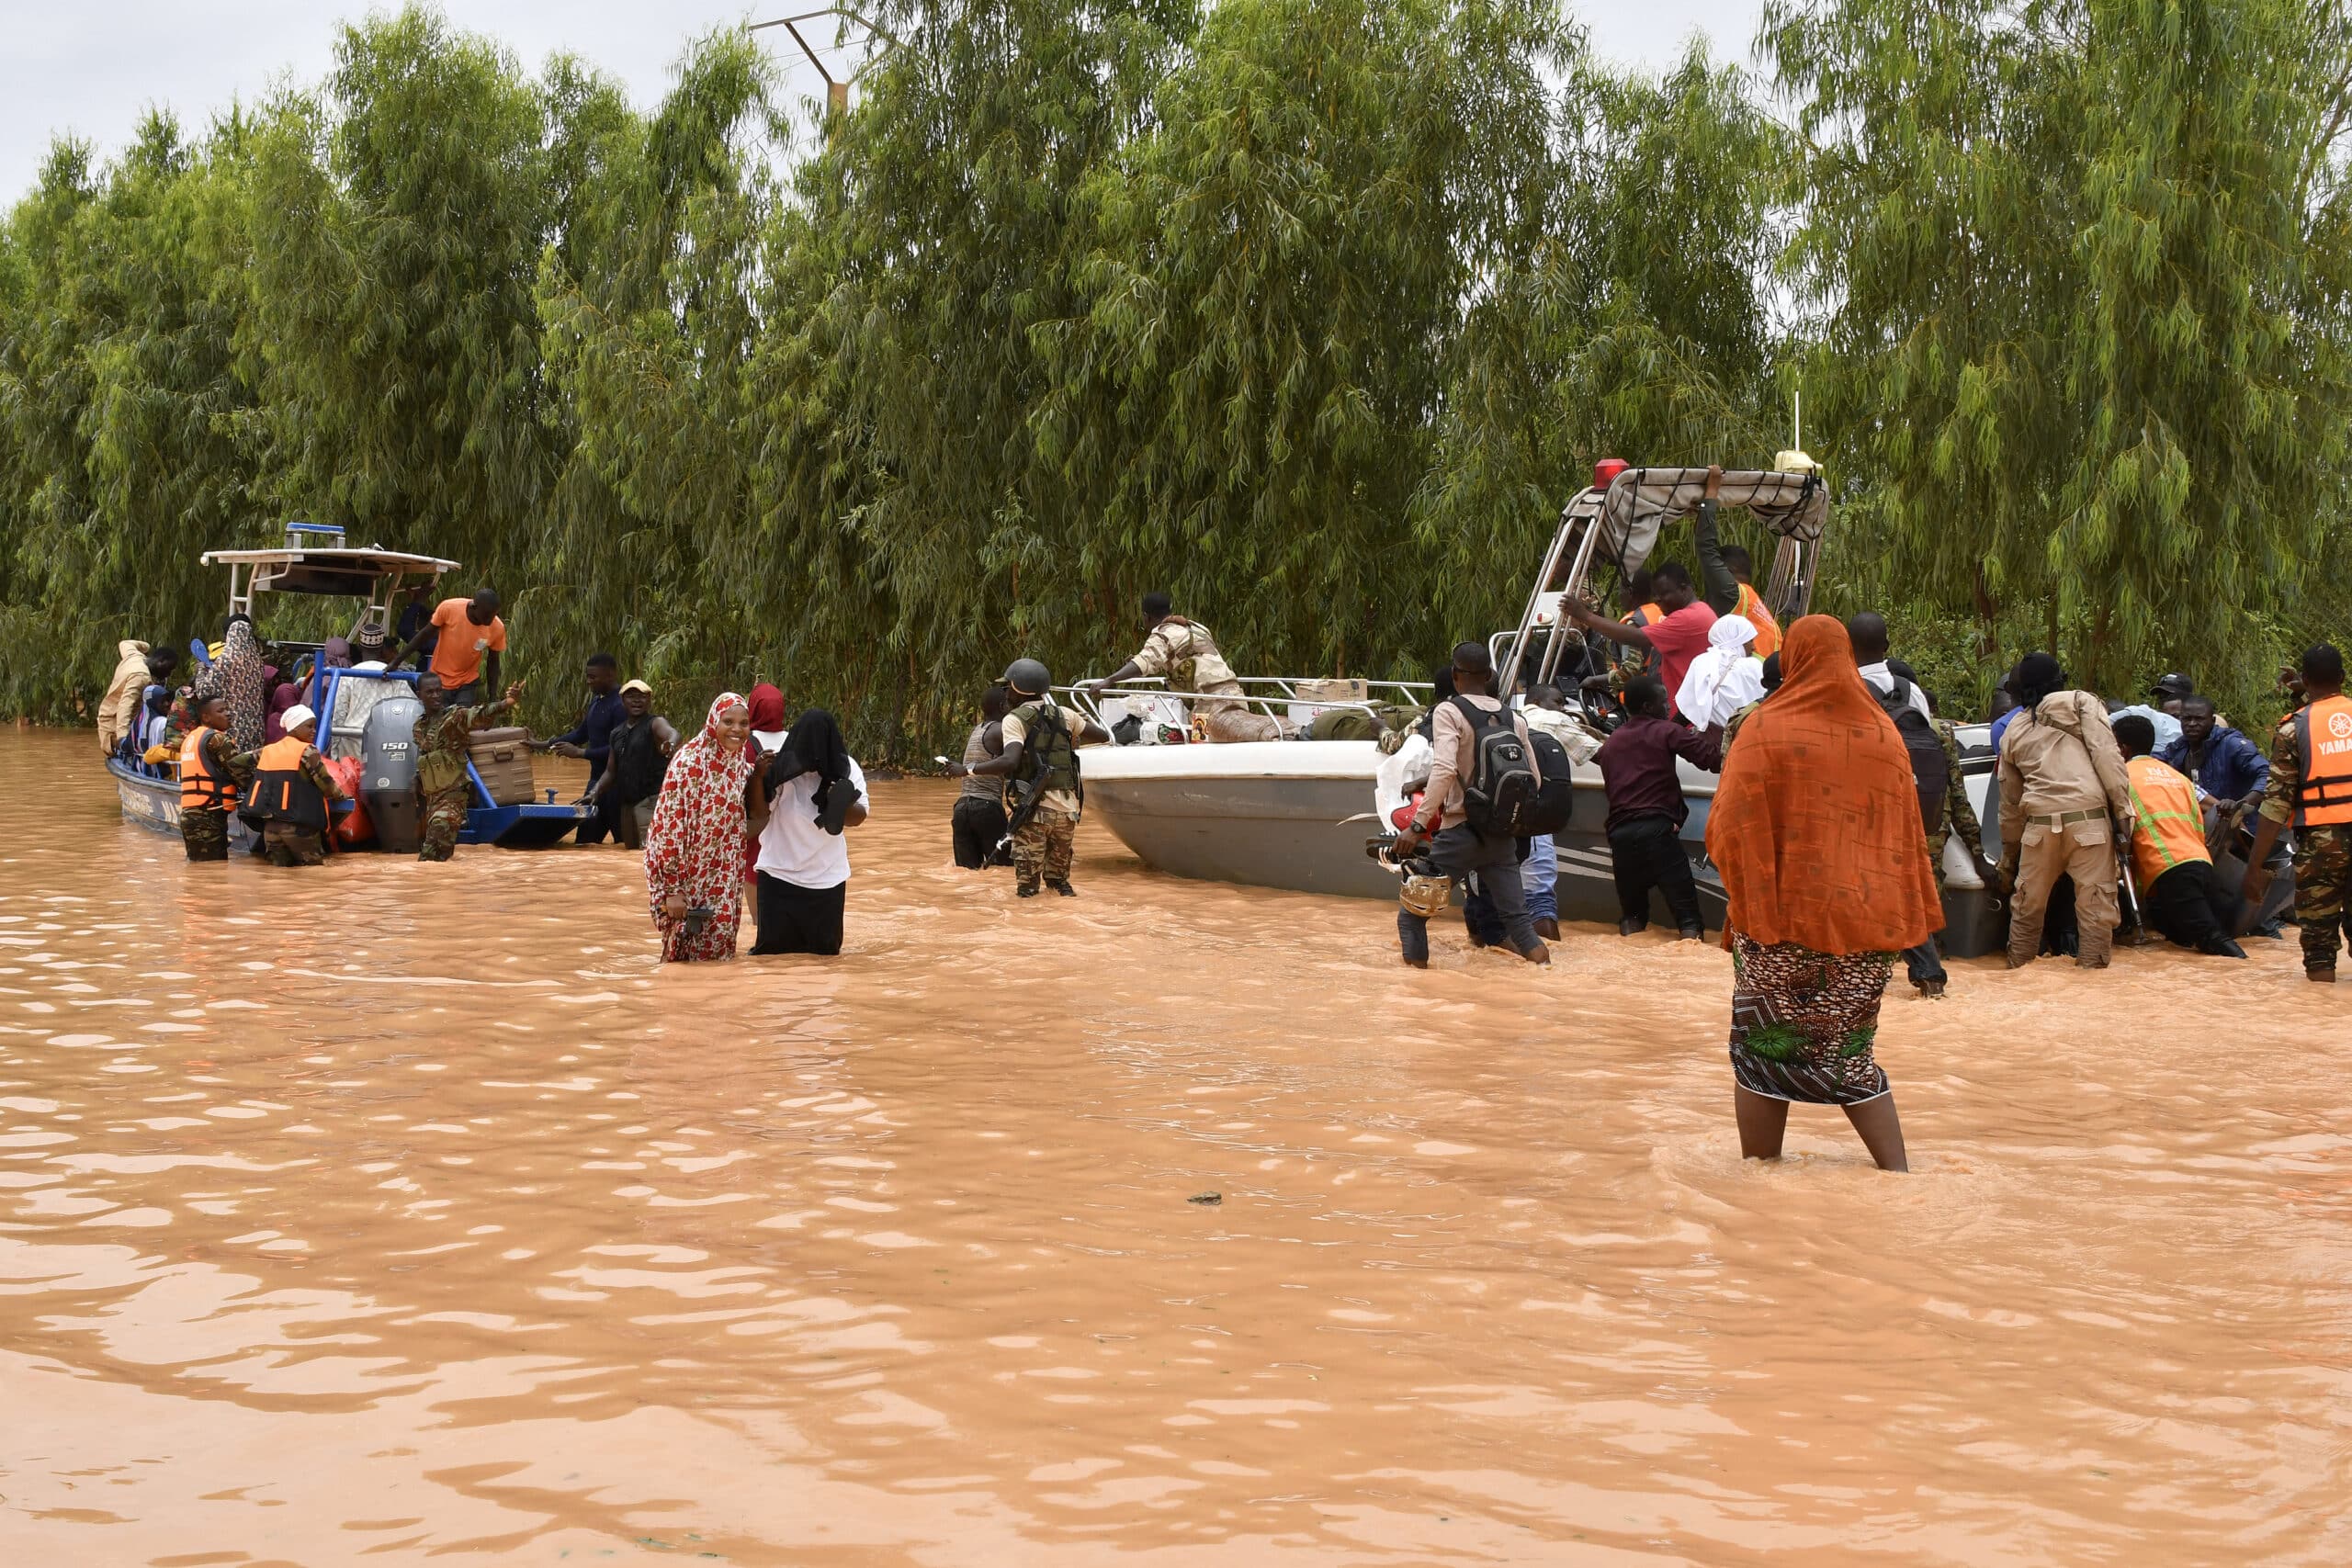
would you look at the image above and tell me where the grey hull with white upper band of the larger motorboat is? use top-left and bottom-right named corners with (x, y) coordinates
top-left (1084, 740), bottom-right (1724, 929)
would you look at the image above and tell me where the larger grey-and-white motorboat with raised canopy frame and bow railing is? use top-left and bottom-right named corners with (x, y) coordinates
top-left (1066, 454), bottom-right (1830, 929)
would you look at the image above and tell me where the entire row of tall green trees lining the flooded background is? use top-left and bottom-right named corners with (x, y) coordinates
top-left (0, 0), bottom-right (2352, 755)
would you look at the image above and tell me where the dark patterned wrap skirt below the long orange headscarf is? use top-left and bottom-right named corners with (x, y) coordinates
top-left (1731, 931), bottom-right (1895, 1105)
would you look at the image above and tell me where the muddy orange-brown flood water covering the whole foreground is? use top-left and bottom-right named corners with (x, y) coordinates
top-left (0, 731), bottom-right (2352, 1568)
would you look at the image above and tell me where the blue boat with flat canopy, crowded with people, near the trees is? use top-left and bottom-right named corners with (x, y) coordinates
top-left (106, 522), bottom-right (579, 851)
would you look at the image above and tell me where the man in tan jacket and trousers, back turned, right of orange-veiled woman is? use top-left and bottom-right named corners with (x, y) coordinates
top-left (2002, 653), bottom-right (2131, 968)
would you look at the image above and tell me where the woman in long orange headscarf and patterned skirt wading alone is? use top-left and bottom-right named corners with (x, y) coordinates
top-left (1708, 616), bottom-right (1943, 1170)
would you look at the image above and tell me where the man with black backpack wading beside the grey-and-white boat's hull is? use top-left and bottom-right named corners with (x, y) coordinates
top-left (1395, 642), bottom-right (1569, 968)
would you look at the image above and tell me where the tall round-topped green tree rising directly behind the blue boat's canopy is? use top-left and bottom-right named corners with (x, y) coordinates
top-left (247, 7), bottom-right (555, 581)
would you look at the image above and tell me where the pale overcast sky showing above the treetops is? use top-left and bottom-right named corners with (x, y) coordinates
top-left (0, 0), bottom-right (1761, 205)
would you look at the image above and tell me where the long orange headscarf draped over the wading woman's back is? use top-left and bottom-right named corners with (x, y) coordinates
top-left (1708, 616), bottom-right (1943, 954)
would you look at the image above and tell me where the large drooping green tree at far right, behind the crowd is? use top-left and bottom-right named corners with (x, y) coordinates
top-left (1764, 0), bottom-right (2352, 689)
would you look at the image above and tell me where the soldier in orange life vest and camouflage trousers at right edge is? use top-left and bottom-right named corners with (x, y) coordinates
top-left (2246, 642), bottom-right (2352, 985)
